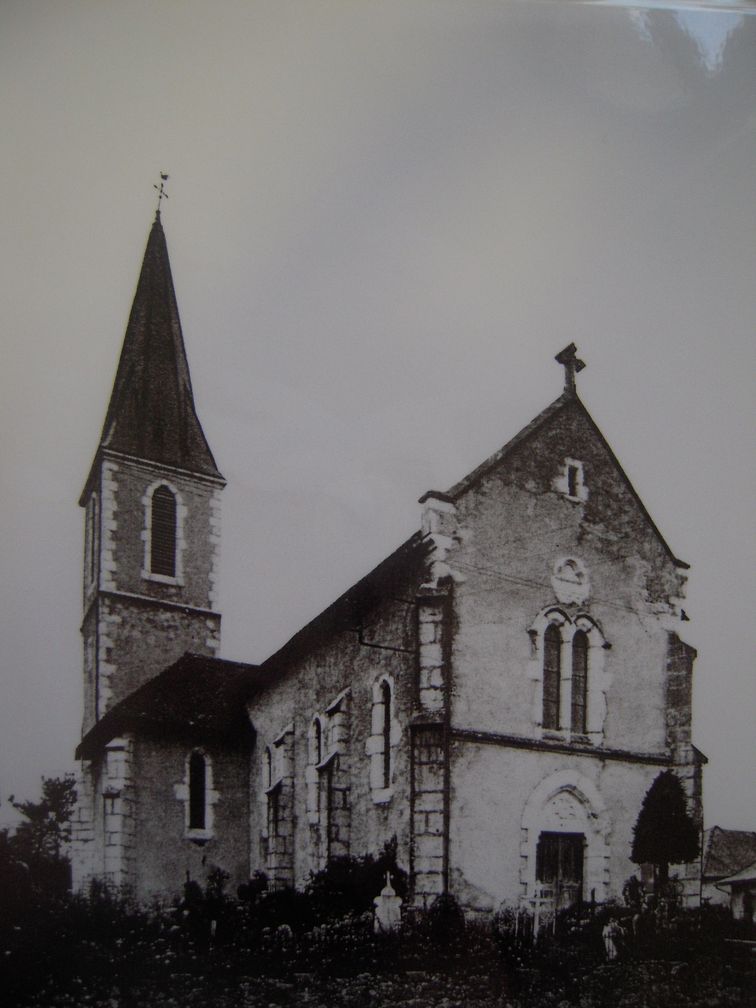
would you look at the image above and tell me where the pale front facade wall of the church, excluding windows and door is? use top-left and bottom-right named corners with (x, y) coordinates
top-left (446, 404), bottom-right (700, 908)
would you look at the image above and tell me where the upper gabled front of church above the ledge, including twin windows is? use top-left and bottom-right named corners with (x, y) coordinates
top-left (437, 379), bottom-right (684, 753)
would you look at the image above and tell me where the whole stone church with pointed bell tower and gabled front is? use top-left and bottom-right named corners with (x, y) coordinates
top-left (74, 212), bottom-right (705, 912)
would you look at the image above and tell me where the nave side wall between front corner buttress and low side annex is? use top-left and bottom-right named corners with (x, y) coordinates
top-left (250, 568), bottom-right (417, 885)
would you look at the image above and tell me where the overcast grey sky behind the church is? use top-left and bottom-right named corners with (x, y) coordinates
top-left (0, 0), bottom-right (756, 829)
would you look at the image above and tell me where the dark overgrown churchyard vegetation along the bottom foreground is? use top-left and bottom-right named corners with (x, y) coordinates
top-left (0, 872), bottom-right (749, 1008)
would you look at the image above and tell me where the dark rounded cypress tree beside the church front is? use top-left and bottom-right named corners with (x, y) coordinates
top-left (630, 770), bottom-right (701, 889)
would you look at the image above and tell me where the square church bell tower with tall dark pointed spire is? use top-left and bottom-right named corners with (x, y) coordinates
top-left (80, 210), bottom-right (225, 734)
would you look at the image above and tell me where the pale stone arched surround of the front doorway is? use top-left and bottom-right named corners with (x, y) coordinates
top-left (520, 769), bottom-right (611, 902)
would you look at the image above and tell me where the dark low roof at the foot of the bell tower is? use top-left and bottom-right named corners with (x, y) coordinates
top-left (77, 652), bottom-right (257, 759)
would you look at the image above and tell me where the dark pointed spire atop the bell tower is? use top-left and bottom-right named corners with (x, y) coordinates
top-left (100, 213), bottom-right (221, 477)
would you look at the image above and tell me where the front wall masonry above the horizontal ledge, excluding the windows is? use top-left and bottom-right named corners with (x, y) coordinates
top-left (450, 406), bottom-right (682, 752)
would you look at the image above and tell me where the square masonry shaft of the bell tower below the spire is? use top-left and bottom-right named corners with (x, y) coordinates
top-left (82, 456), bottom-right (226, 731)
